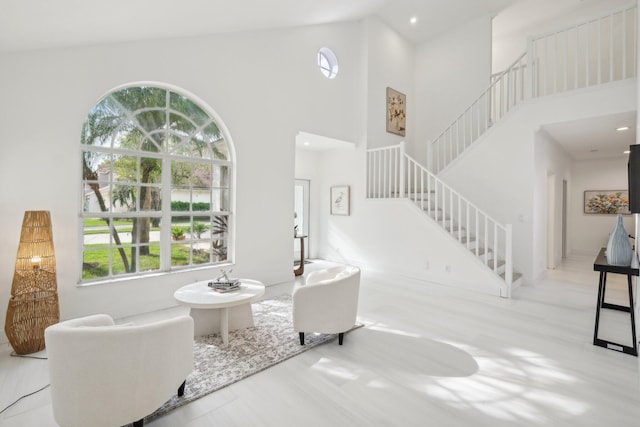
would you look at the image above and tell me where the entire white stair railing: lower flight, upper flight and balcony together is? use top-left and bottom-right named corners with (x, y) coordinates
top-left (367, 4), bottom-right (638, 298)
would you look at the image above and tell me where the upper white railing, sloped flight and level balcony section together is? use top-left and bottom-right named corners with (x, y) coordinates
top-left (427, 4), bottom-right (638, 173)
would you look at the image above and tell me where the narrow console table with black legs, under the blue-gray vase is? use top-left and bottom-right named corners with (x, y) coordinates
top-left (593, 248), bottom-right (640, 356)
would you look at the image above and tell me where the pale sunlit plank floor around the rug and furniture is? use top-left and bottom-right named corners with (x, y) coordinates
top-left (0, 257), bottom-right (640, 427)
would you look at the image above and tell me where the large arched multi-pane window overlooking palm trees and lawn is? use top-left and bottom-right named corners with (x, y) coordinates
top-left (81, 85), bottom-right (233, 282)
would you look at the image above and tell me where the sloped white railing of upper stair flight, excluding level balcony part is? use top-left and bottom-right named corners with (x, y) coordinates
top-left (428, 52), bottom-right (530, 173)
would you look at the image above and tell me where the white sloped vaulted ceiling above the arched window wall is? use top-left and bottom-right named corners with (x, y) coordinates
top-left (0, 0), bottom-right (516, 52)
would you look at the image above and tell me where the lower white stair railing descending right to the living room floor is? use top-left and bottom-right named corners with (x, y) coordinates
top-left (367, 142), bottom-right (513, 297)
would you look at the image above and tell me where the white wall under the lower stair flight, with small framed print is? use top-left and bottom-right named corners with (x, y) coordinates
top-left (319, 148), bottom-right (500, 296)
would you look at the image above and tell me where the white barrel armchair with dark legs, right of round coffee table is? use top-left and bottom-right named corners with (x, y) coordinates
top-left (292, 265), bottom-right (360, 345)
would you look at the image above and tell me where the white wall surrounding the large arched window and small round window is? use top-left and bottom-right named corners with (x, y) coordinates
top-left (0, 23), bottom-right (364, 340)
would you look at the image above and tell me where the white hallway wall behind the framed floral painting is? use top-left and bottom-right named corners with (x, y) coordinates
top-left (569, 158), bottom-right (635, 258)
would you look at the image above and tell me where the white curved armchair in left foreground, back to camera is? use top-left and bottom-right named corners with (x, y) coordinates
top-left (45, 314), bottom-right (193, 427)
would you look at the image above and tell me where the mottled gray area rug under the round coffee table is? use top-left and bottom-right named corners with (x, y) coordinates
top-left (138, 295), bottom-right (361, 422)
